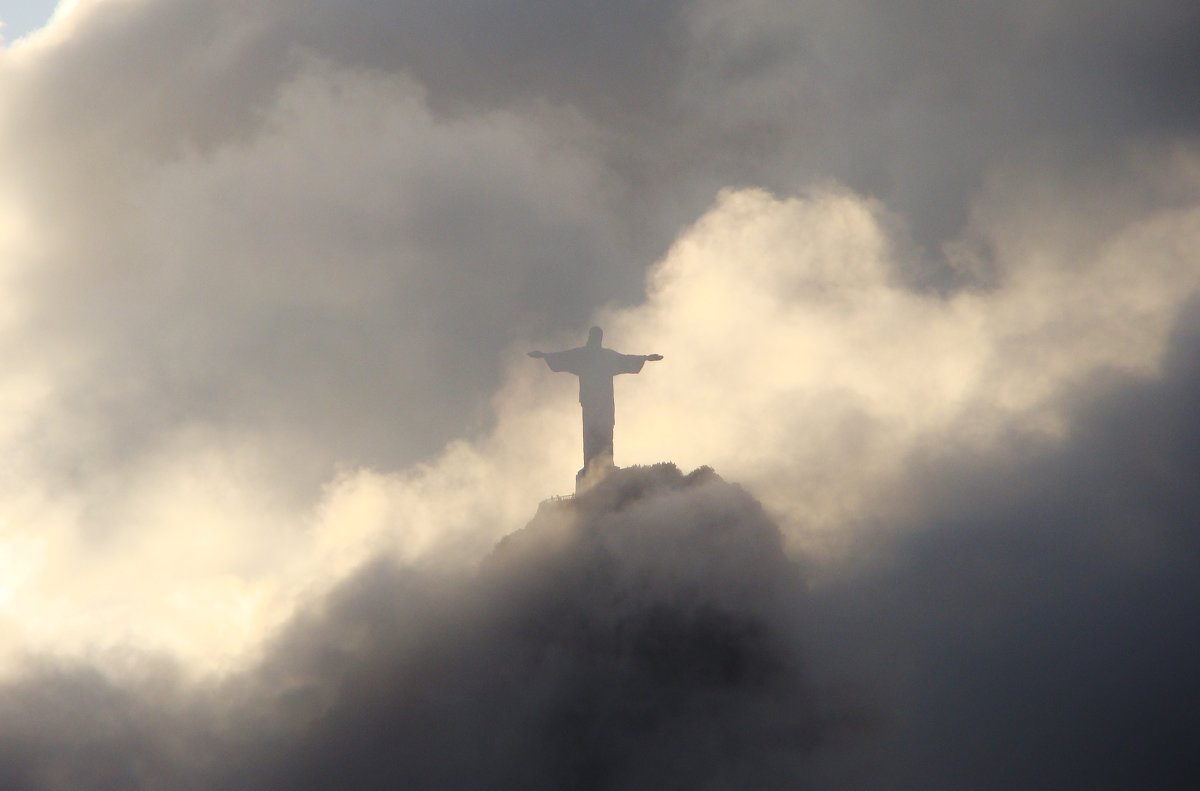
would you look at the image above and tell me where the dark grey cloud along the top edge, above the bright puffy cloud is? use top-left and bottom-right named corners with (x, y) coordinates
top-left (285, 0), bottom-right (1200, 266)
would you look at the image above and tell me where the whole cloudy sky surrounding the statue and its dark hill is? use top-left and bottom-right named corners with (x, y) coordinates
top-left (0, 0), bottom-right (1200, 787)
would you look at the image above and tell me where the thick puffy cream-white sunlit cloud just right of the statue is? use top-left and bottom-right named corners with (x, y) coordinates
top-left (612, 174), bottom-right (1200, 535)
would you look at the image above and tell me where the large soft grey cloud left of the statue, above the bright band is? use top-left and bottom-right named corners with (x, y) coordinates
top-left (2, 55), bottom-right (605, 473)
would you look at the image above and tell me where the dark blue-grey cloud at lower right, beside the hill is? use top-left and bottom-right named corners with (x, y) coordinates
top-left (816, 302), bottom-right (1200, 789)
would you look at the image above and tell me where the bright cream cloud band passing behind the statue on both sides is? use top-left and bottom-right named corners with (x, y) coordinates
top-left (2, 172), bottom-right (1198, 670)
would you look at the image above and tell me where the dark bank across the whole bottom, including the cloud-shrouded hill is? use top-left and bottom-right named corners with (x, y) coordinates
top-left (0, 324), bottom-right (1200, 789)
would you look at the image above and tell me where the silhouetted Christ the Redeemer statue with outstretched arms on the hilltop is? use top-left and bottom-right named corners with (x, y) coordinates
top-left (529, 326), bottom-right (662, 484)
